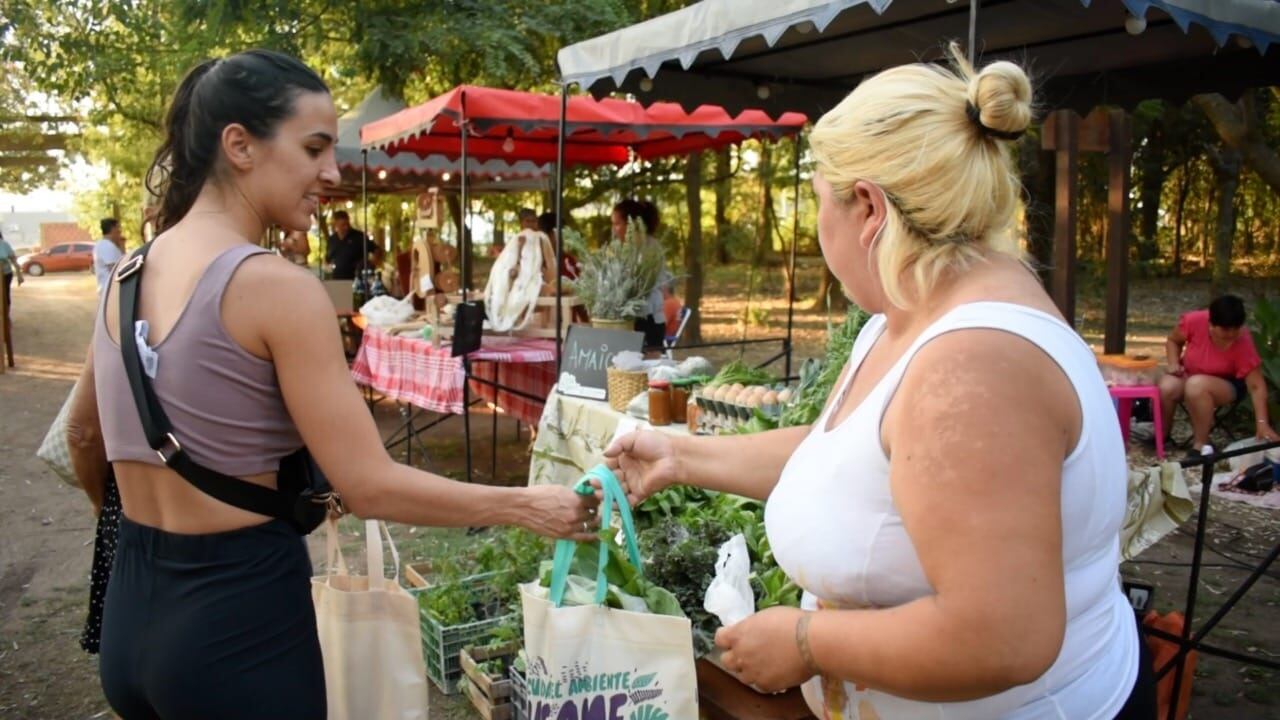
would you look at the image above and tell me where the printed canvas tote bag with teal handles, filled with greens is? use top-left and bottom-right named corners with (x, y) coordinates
top-left (520, 465), bottom-right (698, 720)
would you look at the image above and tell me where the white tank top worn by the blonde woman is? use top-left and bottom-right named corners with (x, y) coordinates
top-left (764, 302), bottom-right (1138, 720)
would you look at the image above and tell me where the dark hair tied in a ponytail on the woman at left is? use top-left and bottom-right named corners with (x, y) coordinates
top-left (146, 50), bottom-right (329, 232)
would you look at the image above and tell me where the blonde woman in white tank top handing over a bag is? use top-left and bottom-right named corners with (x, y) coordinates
top-left (608, 49), bottom-right (1155, 720)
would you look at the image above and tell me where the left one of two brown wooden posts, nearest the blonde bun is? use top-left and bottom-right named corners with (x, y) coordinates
top-left (1050, 110), bottom-right (1080, 327)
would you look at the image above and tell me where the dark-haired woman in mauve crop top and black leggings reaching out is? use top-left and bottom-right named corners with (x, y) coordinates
top-left (68, 50), bottom-right (595, 720)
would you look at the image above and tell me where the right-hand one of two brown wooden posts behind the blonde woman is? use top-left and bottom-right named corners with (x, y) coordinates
top-left (1103, 110), bottom-right (1133, 355)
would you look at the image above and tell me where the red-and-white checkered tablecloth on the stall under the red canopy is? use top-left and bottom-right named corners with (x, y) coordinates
top-left (351, 327), bottom-right (556, 425)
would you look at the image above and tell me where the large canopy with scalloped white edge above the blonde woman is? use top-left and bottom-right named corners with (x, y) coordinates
top-left (558, 0), bottom-right (1280, 117)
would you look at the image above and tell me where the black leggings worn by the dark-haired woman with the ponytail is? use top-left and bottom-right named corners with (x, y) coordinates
top-left (99, 516), bottom-right (325, 720)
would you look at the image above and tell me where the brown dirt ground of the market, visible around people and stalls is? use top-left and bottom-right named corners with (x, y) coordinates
top-left (0, 268), bottom-right (1280, 720)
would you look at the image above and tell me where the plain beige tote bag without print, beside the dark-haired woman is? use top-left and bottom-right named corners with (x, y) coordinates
top-left (311, 519), bottom-right (428, 720)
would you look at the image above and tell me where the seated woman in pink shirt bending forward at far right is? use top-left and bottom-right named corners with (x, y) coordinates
top-left (1160, 295), bottom-right (1280, 455)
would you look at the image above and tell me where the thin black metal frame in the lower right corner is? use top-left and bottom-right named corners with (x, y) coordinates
top-left (1143, 442), bottom-right (1280, 720)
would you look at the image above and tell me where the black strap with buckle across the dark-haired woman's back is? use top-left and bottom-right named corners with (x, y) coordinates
top-left (115, 242), bottom-right (292, 520)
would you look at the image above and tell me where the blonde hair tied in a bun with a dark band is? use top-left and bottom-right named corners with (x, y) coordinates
top-left (809, 44), bottom-right (1032, 307)
